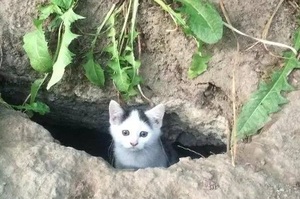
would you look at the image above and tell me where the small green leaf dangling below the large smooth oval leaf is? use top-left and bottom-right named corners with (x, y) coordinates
top-left (188, 52), bottom-right (210, 79)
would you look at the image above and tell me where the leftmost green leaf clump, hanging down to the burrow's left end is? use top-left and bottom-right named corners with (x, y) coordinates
top-left (21, 0), bottom-right (83, 114)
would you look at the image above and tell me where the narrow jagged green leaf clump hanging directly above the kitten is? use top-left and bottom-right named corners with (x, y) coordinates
top-left (106, 0), bottom-right (141, 99)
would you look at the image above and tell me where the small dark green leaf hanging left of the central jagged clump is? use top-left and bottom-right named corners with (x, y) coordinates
top-left (83, 52), bottom-right (105, 87)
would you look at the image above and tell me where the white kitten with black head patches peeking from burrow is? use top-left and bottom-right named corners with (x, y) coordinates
top-left (109, 100), bottom-right (175, 169)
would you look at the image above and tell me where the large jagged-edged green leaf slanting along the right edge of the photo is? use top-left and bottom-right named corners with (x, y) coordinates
top-left (237, 53), bottom-right (300, 139)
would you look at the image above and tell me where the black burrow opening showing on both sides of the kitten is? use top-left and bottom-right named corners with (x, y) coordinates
top-left (32, 116), bottom-right (226, 166)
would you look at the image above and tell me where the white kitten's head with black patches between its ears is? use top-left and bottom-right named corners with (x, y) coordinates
top-left (109, 100), bottom-right (165, 151)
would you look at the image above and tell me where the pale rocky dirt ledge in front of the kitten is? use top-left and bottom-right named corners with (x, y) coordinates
top-left (0, 107), bottom-right (300, 199)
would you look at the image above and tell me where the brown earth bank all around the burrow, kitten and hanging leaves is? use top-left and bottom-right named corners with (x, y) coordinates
top-left (0, 0), bottom-right (300, 198)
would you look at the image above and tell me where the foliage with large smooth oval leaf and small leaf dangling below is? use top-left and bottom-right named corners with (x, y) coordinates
top-left (154, 0), bottom-right (223, 79)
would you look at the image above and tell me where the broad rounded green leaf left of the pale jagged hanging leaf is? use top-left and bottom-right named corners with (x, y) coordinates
top-left (23, 20), bottom-right (52, 73)
